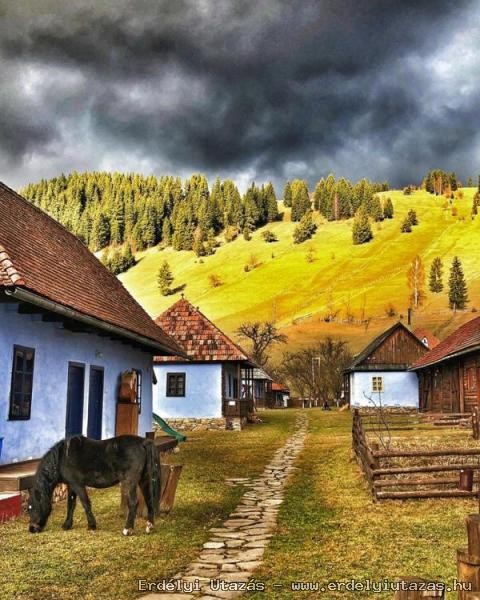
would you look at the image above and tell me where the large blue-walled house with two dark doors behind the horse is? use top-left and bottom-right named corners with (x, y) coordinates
top-left (0, 184), bottom-right (181, 464)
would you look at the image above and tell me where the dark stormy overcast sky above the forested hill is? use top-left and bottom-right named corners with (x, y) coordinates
top-left (0, 0), bottom-right (480, 187)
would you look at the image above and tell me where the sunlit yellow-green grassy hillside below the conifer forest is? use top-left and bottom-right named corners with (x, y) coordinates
top-left (121, 188), bottom-right (480, 351)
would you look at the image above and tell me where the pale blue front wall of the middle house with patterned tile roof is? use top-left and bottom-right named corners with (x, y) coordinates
top-left (153, 363), bottom-right (222, 418)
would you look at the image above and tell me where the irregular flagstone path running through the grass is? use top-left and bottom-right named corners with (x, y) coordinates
top-left (141, 414), bottom-right (308, 600)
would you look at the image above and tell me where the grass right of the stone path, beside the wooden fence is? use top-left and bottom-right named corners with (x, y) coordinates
top-left (249, 409), bottom-right (478, 600)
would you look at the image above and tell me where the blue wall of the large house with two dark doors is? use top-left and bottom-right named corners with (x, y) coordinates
top-left (0, 304), bottom-right (152, 463)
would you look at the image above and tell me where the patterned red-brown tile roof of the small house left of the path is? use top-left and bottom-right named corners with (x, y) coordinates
top-left (155, 298), bottom-right (253, 364)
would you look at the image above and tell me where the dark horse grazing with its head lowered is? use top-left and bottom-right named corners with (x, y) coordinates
top-left (29, 435), bottom-right (160, 535)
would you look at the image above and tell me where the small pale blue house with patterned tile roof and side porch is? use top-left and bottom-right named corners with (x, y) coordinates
top-left (153, 298), bottom-right (254, 426)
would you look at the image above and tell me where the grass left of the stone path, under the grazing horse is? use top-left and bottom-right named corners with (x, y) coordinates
top-left (0, 411), bottom-right (295, 600)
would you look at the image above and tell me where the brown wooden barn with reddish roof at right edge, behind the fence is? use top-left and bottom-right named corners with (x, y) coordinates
top-left (411, 317), bottom-right (480, 413)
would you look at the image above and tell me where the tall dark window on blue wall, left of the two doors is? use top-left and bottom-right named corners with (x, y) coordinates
top-left (8, 346), bottom-right (35, 420)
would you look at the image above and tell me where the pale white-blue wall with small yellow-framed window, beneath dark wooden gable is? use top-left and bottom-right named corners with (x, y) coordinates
top-left (350, 371), bottom-right (418, 407)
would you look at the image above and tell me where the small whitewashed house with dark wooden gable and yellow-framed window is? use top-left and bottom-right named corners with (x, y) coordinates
top-left (344, 322), bottom-right (428, 408)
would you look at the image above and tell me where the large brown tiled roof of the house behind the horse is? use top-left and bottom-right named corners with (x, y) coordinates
top-left (0, 183), bottom-right (179, 354)
